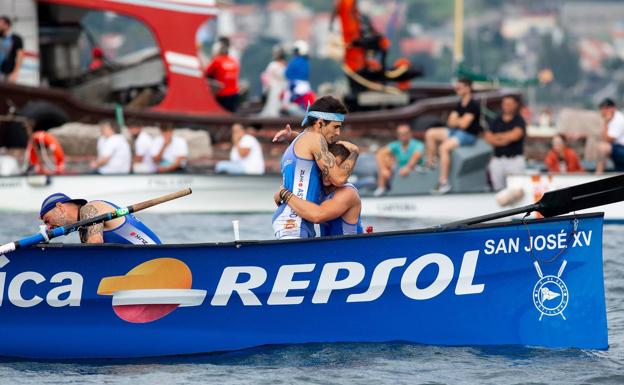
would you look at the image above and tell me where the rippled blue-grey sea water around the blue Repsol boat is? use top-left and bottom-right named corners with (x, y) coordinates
top-left (0, 214), bottom-right (624, 385)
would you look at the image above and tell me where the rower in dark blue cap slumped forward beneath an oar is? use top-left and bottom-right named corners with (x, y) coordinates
top-left (39, 193), bottom-right (162, 245)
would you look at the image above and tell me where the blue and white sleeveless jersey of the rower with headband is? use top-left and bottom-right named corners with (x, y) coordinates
top-left (273, 133), bottom-right (321, 239)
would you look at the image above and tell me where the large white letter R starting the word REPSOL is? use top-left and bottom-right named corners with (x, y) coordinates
top-left (210, 266), bottom-right (267, 306)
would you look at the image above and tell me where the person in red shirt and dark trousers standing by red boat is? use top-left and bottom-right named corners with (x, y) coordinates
top-left (205, 38), bottom-right (240, 112)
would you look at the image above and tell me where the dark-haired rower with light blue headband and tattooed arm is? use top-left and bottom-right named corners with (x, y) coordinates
top-left (273, 96), bottom-right (359, 239)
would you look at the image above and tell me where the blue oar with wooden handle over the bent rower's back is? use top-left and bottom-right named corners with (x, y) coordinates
top-left (0, 188), bottom-right (192, 255)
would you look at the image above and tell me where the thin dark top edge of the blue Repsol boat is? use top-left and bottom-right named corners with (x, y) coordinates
top-left (32, 212), bottom-right (604, 251)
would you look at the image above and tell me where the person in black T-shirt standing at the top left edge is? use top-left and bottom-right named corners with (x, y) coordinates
top-left (0, 16), bottom-right (24, 83)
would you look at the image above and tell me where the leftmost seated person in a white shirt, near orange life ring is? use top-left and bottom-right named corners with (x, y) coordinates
top-left (91, 120), bottom-right (132, 174)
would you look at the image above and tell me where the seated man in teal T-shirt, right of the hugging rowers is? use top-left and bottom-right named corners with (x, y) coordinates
top-left (374, 123), bottom-right (425, 196)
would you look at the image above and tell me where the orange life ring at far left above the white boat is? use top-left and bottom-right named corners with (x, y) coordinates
top-left (26, 131), bottom-right (65, 174)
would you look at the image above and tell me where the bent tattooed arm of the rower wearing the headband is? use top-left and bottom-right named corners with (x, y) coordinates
top-left (311, 134), bottom-right (359, 186)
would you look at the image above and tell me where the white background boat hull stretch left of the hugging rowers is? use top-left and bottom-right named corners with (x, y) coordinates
top-left (0, 174), bottom-right (281, 213)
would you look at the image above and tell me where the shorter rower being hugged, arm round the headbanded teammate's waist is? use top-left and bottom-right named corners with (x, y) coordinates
top-left (276, 143), bottom-right (363, 236)
